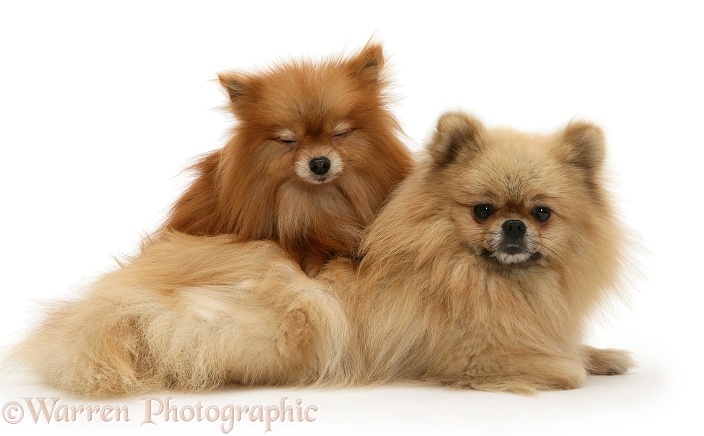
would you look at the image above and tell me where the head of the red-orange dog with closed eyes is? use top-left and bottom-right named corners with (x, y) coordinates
top-left (219, 44), bottom-right (406, 185)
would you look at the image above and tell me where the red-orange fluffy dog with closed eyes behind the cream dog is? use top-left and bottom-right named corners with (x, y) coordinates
top-left (164, 44), bottom-right (412, 273)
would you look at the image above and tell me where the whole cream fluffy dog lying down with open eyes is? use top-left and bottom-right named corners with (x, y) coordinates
top-left (15, 113), bottom-right (633, 396)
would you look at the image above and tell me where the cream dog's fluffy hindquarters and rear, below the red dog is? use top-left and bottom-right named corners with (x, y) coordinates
top-left (13, 237), bottom-right (350, 397)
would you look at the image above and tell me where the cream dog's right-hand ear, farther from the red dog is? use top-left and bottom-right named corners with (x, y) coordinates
top-left (557, 121), bottom-right (606, 172)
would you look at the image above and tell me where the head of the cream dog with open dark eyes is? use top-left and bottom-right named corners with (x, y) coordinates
top-left (428, 113), bottom-right (610, 269)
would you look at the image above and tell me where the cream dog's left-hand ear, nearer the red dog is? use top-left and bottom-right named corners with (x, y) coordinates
top-left (428, 112), bottom-right (484, 167)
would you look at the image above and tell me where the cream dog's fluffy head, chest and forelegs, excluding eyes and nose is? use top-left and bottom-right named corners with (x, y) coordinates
top-left (351, 113), bottom-right (632, 393)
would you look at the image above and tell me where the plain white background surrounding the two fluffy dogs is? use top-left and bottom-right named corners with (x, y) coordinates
top-left (0, 0), bottom-right (704, 435)
